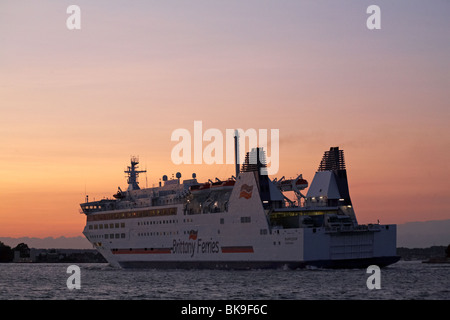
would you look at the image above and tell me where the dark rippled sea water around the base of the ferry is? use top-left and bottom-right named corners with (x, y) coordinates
top-left (0, 261), bottom-right (450, 300)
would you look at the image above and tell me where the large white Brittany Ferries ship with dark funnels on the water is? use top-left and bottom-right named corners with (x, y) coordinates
top-left (80, 147), bottom-right (399, 269)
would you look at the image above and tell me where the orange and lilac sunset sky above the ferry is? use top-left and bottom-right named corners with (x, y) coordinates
top-left (0, 0), bottom-right (450, 237)
